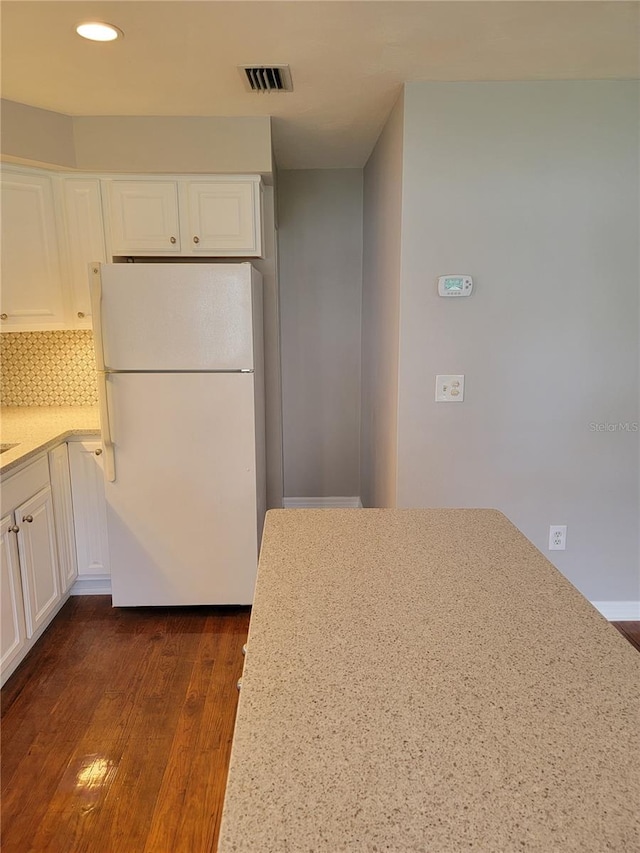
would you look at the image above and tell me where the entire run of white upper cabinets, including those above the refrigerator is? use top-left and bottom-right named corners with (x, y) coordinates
top-left (0, 165), bottom-right (263, 332)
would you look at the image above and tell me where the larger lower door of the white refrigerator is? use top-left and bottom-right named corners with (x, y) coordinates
top-left (105, 373), bottom-right (261, 606)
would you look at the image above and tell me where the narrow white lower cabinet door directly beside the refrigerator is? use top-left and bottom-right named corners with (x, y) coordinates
top-left (69, 441), bottom-right (109, 578)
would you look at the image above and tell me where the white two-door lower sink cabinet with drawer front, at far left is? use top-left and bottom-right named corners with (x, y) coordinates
top-left (1, 456), bottom-right (64, 683)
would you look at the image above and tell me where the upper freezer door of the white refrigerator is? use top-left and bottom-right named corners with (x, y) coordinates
top-left (98, 263), bottom-right (254, 371)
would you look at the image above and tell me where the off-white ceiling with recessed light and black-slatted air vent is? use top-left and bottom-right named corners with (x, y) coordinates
top-left (1, 0), bottom-right (640, 169)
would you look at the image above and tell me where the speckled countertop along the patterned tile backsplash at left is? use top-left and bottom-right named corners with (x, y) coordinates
top-left (0, 406), bottom-right (100, 474)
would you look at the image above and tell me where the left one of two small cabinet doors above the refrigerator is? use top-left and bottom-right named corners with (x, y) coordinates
top-left (104, 180), bottom-right (180, 255)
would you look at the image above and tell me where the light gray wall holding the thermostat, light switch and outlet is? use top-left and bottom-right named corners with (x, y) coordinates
top-left (398, 81), bottom-right (640, 601)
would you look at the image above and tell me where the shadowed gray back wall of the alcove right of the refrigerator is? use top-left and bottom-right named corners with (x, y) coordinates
top-left (278, 169), bottom-right (362, 497)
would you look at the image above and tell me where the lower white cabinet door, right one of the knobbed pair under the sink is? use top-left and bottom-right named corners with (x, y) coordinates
top-left (15, 486), bottom-right (62, 637)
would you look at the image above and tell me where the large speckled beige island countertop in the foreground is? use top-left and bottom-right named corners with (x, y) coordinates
top-left (218, 509), bottom-right (640, 853)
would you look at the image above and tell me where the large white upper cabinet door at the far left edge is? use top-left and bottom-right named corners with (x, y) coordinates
top-left (0, 170), bottom-right (66, 332)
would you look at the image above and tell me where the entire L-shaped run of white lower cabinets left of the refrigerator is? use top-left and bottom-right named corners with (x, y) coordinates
top-left (0, 441), bottom-right (111, 684)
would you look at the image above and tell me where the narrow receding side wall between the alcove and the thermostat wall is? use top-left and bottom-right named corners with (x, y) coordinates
top-left (360, 97), bottom-right (404, 507)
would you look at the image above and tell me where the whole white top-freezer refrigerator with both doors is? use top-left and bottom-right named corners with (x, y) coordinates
top-left (91, 263), bottom-right (265, 606)
